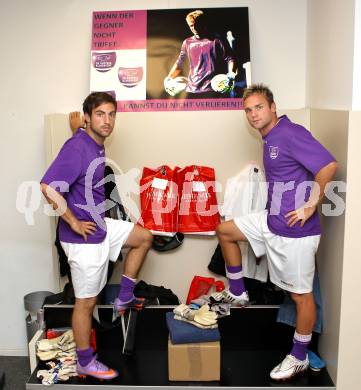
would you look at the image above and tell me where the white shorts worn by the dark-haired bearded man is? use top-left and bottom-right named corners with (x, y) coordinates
top-left (61, 218), bottom-right (134, 298)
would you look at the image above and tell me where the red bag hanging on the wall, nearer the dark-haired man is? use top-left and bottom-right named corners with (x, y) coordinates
top-left (138, 165), bottom-right (179, 235)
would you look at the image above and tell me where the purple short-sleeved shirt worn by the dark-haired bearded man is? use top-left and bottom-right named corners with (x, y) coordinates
top-left (41, 129), bottom-right (106, 244)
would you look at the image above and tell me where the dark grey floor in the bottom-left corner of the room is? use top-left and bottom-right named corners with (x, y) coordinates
top-left (0, 356), bottom-right (30, 390)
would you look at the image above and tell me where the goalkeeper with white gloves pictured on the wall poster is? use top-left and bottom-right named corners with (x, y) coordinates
top-left (164, 10), bottom-right (237, 99)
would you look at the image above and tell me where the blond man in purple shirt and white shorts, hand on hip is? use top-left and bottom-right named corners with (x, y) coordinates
top-left (217, 84), bottom-right (337, 380)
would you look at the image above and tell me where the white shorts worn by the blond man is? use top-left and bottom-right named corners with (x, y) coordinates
top-left (234, 210), bottom-right (321, 294)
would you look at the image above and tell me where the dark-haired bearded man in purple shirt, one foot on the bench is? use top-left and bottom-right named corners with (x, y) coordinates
top-left (41, 92), bottom-right (152, 379)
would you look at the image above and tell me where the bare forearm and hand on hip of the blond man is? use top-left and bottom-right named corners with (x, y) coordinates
top-left (286, 161), bottom-right (337, 227)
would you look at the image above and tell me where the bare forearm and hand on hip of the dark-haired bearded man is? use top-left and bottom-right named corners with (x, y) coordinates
top-left (40, 183), bottom-right (96, 241)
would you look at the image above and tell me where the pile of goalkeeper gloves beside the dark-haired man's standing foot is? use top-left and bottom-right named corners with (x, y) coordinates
top-left (36, 330), bottom-right (78, 386)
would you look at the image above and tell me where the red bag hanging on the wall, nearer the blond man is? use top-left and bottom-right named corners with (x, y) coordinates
top-left (178, 165), bottom-right (220, 235)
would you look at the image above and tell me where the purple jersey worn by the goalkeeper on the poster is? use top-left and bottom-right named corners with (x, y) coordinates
top-left (177, 36), bottom-right (234, 93)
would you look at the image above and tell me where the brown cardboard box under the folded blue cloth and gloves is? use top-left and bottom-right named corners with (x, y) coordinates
top-left (168, 339), bottom-right (221, 381)
